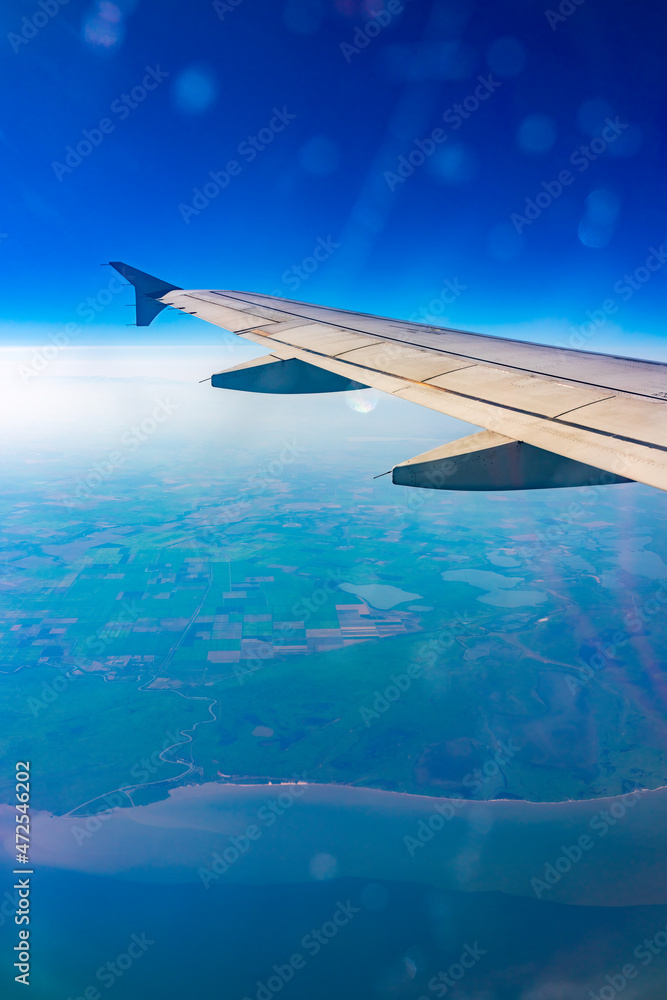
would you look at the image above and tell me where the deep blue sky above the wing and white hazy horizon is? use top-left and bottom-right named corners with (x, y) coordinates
top-left (0, 0), bottom-right (667, 357)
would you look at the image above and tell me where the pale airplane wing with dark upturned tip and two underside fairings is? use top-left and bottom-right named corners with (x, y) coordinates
top-left (112, 262), bottom-right (667, 490)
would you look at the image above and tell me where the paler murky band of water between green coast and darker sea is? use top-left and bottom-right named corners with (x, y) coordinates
top-left (0, 781), bottom-right (667, 906)
